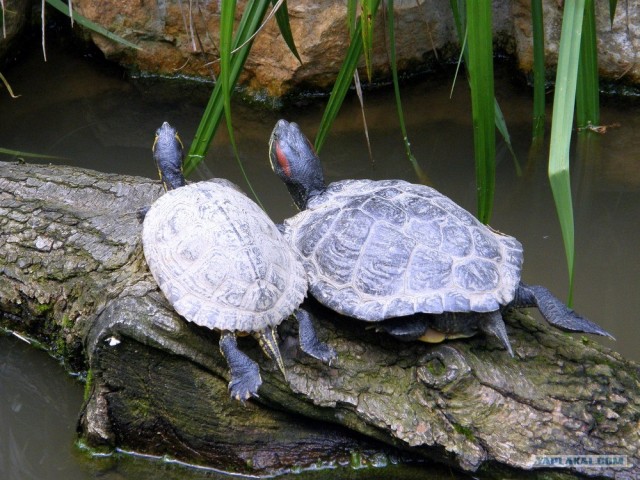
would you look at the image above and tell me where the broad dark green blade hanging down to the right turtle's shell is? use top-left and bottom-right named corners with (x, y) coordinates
top-left (466, 0), bottom-right (496, 223)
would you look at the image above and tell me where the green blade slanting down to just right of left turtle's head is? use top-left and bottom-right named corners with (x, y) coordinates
top-left (184, 0), bottom-right (270, 175)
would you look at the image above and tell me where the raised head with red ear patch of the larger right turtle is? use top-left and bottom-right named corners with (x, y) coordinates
top-left (269, 120), bottom-right (325, 210)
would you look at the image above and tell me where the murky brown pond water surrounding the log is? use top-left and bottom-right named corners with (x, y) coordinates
top-left (0, 39), bottom-right (640, 480)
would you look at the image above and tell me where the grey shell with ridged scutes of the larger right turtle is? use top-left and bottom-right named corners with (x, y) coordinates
top-left (285, 180), bottom-right (523, 321)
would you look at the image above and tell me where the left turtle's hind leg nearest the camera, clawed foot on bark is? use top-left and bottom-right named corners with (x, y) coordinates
top-left (220, 331), bottom-right (262, 402)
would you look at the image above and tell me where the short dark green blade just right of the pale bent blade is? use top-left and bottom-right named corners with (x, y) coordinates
top-left (576, 0), bottom-right (600, 129)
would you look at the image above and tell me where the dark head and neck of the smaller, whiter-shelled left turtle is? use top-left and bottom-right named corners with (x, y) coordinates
top-left (151, 122), bottom-right (185, 190)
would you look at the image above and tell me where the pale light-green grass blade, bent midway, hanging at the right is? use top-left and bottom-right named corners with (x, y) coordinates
top-left (549, 0), bottom-right (585, 303)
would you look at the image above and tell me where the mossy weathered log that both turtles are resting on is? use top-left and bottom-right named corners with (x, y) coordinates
top-left (0, 162), bottom-right (640, 478)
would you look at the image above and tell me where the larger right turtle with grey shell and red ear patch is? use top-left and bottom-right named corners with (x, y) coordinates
top-left (269, 120), bottom-right (611, 354)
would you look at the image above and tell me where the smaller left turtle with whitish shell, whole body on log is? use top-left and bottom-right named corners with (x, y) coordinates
top-left (142, 122), bottom-right (335, 401)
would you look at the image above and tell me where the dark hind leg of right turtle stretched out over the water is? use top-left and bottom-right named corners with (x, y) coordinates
top-left (510, 282), bottom-right (614, 338)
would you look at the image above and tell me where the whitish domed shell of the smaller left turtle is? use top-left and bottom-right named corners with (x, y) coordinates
top-left (142, 181), bottom-right (307, 332)
